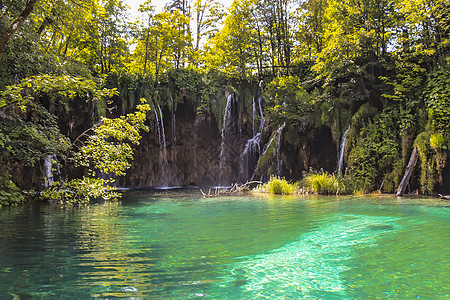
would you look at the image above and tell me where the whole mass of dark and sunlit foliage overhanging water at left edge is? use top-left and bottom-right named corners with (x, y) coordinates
top-left (0, 75), bottom-right (150, 204)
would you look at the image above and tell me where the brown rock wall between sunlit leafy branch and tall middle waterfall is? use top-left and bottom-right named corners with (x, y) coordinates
top-left (126, 99), bottom-right (225, 187)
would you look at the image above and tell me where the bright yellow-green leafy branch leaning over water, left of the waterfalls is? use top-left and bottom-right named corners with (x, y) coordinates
top-left (42, 99), bottom-right (150, 204)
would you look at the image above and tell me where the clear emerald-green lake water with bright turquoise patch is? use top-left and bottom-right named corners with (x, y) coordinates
top-left (0, 192), bottom-right (450, 299)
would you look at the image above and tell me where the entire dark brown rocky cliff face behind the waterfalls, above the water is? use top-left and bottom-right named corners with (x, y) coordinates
top-left (122, 95), bottom-right (337, 187)
